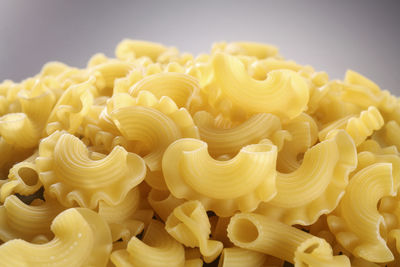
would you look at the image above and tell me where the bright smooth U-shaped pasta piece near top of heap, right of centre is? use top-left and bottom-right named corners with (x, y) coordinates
top-left (213, 53), bottom-right (309, 119)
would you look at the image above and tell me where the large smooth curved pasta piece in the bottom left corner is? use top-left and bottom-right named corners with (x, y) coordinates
top-left (0, 208), bottom-right (111, 267)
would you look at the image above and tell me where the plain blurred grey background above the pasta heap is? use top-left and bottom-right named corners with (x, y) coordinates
top-left (0, 0), bottom-right (400, 95)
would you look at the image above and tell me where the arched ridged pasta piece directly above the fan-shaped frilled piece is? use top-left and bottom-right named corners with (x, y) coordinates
top-left (129, 72), bottom-right (199, 107)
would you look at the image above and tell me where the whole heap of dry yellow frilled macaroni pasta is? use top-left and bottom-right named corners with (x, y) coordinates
top-left (0, 40), bottom-right (400, 267)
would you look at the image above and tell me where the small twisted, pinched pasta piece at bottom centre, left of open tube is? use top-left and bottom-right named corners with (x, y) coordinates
top-left (165, 200), bottom-right (223, 263)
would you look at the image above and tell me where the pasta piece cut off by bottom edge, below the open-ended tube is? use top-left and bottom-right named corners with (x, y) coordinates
top-left (218, 247), bottom-right (267, 267)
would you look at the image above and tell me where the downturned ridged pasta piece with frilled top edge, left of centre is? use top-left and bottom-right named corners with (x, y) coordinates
top-left (110, 91), bottom-right (199, 171)
